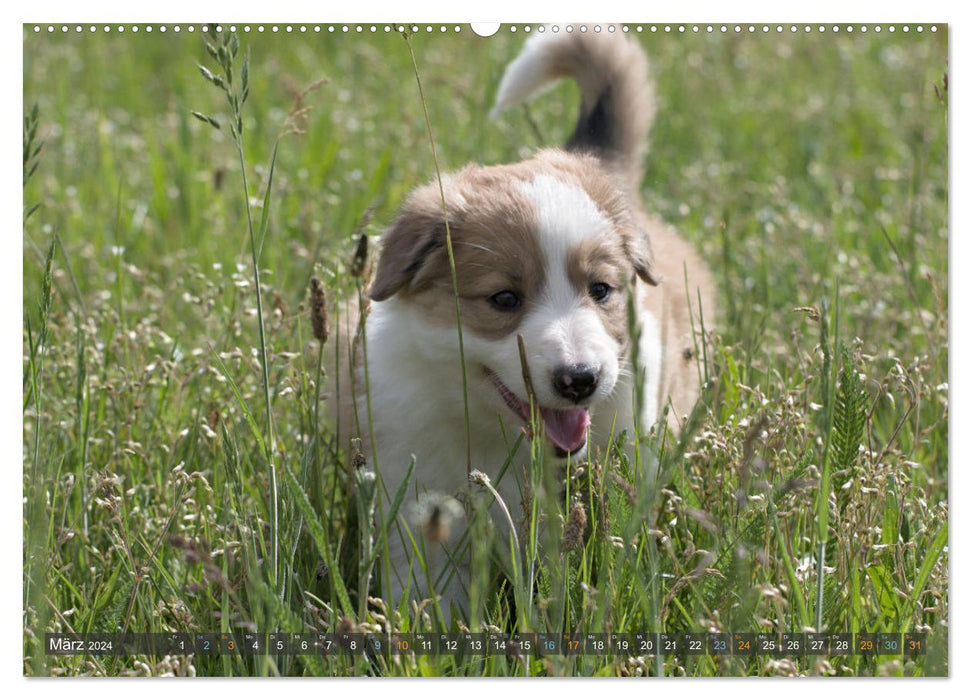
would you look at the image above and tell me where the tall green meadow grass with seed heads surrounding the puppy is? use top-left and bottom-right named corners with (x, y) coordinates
top-left (23, 28), bottom-right (948, 676)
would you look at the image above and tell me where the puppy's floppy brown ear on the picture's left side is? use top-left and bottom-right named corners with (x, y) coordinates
top-left (368, 198), bottom-right (445, 301)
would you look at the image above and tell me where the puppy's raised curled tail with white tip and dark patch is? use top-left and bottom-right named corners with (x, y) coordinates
top-left (492, 27), bottom-right (656, 189)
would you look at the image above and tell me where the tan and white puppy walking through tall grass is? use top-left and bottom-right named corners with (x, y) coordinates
top-left (340, 32), bottom-right (714, 615)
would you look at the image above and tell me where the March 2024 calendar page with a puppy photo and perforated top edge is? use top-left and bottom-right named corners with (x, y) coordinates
top-left (21, 12), bottom-right (950, 682)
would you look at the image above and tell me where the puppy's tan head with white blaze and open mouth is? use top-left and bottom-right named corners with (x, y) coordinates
top-left (370, 151), bottom-right (656, 456)
